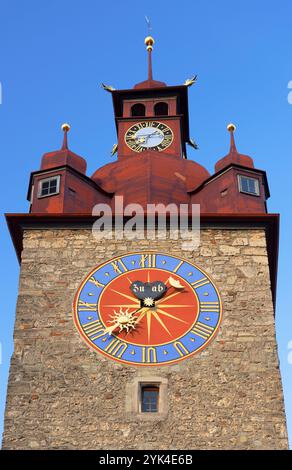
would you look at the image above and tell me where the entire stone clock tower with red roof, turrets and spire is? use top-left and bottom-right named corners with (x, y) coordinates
top-left (3, 36), bottom-right (287, 450)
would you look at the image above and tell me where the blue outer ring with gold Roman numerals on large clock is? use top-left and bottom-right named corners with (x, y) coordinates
top-left (74, 252), bottom-right (222, 366)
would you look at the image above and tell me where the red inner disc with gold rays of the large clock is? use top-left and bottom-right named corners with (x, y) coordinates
top-left (98, 268), bottom-right (199, 346)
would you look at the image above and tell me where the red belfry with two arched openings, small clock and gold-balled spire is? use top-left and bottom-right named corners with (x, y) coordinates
top-left (112, 36), bottom-right (189, 158)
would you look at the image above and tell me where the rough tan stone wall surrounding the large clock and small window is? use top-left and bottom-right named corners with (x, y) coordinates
top-left (3, 229), bottom-right (288, 449)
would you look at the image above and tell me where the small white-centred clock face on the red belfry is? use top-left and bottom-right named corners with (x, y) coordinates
top-left (125, 121), bottom-right (173, 152)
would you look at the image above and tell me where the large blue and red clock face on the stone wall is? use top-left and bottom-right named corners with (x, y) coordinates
top-left (74, 253), bottom-right (222, 366)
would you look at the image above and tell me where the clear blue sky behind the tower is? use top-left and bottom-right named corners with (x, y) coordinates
top-left (0, 0), bottom-right (292, 445)
